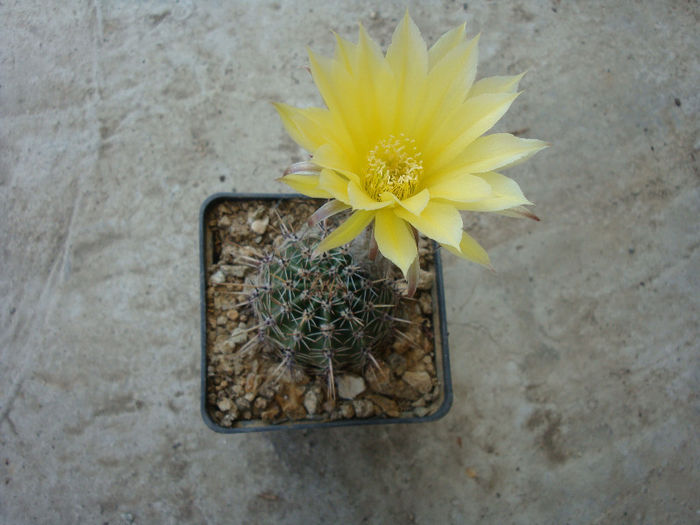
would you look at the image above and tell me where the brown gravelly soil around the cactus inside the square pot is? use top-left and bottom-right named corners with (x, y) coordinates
top-left (204, 198), bottom-right (444, 428)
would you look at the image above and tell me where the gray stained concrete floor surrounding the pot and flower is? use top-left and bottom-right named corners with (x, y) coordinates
top-left (0, 0), bottom-right (700, 524)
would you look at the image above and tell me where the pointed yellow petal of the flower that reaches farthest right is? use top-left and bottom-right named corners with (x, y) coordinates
top-left (440, 133), bottom-right (549, 173)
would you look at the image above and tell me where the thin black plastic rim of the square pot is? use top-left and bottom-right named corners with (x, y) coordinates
top-left (199, 193), bottom-right (452, 434)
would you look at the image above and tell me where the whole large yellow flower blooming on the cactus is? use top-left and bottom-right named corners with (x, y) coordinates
top-left (275, 12), bottom-right (547, 281)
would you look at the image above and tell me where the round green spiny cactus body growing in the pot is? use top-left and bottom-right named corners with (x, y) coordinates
top-left (250, 232), bottom-right (398, 380)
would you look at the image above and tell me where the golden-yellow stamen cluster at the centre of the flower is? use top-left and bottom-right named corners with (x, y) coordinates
top-left (365, 133), bottom-right (423, 200)
